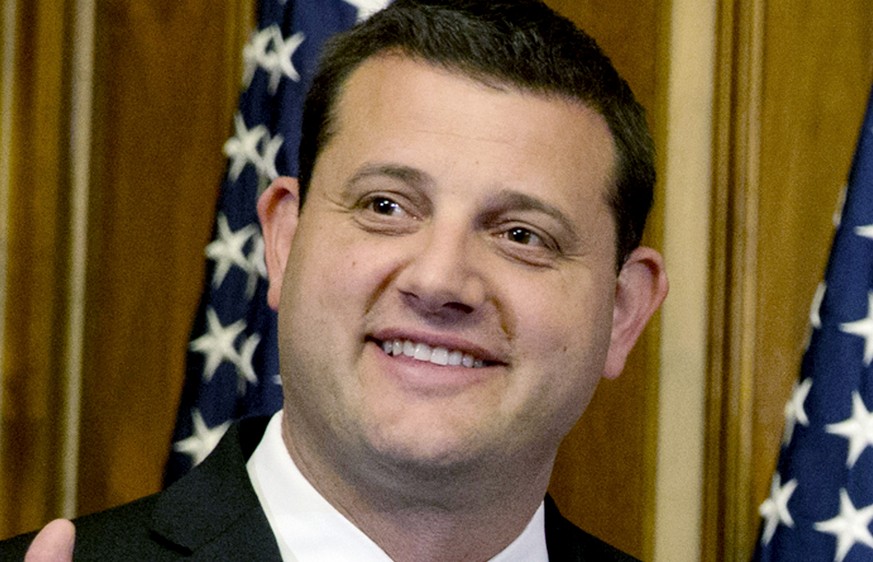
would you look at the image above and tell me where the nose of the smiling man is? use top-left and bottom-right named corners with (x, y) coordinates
top-left (397, 225), bottom-right (486, 319)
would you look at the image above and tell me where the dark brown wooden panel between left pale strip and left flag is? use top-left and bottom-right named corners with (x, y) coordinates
top-left (79, 0), bottom-right (253, 513)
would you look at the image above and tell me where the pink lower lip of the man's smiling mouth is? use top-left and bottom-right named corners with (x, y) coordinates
top-left (367, 336), bottom-right (500, 395)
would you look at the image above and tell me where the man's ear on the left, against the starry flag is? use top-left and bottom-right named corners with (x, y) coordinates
top-left (258, 177), bottom-right (300, 310)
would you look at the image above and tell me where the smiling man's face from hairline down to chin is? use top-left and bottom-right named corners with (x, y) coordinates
top-left (258, 56), bottom-right (660, 476)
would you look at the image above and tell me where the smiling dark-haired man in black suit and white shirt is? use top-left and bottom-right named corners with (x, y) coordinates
top-left (0, 0), bottom-right (667, 562)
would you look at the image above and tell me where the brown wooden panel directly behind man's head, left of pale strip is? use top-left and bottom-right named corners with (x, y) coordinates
top-left (547, 0), bottom-right (666, 559)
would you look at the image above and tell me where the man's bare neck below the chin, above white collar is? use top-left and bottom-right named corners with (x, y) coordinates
top-left (283, 418), bottom-right (552, 562)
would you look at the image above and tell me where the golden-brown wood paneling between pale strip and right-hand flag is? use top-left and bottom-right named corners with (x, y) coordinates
top-left (704, 0), bottom-right (873, 560)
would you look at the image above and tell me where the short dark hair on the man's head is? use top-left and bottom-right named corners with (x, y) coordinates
top-left (299, 0), bottom-right (655, 267)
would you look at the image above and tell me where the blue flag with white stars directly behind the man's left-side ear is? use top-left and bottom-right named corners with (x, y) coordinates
top-left (164, 0), bottom-right (390, 484)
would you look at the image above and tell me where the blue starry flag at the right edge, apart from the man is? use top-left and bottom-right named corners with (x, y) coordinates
top-left (755, 87), bottom-right (873, 562)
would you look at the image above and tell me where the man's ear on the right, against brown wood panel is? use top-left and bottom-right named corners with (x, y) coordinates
top-left (604, 247), bottom-right (669, 379)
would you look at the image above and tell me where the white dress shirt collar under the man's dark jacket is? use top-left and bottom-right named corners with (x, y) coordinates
top-left (246, 411), bottom-right (548, 562)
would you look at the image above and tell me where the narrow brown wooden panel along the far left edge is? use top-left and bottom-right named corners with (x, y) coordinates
top-left (0, 2), bottom-right (70, 536)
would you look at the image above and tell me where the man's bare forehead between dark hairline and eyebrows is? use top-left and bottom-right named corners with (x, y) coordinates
top-left (324, 54), bottom-right (615, 212)
